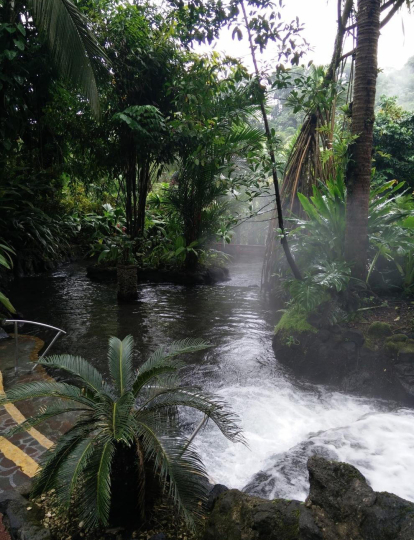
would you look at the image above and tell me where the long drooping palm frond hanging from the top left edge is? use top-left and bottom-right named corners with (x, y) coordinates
top-left (30, 0), bottom-right (108, 116)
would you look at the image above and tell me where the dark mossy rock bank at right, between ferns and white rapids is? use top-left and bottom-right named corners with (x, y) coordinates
top-left (273, 303), bottom-right (414, 406)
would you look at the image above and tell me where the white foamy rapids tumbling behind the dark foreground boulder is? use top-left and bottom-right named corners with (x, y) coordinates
top-left (197, 375), bottom-right (414, 501)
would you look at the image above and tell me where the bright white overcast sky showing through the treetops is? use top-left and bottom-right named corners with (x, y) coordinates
top-left (197, 0), bottom-right (414, 69)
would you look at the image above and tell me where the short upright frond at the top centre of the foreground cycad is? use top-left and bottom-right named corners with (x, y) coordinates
top-left (108, 336), bottom-right (134, 396)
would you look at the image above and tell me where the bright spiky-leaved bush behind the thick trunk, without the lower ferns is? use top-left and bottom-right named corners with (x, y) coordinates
top-left (291, 175), bottom-right (414, 291)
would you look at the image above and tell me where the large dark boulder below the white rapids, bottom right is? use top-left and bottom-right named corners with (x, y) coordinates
top-left (204, 456), bottom-right (414, 540)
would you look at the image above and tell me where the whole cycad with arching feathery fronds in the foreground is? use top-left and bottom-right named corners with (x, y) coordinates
top-left (3, 336), bottom-right (242, 529)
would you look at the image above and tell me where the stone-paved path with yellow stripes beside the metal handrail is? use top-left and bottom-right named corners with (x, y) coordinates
top-left (0, 335), bottom-right (55, 496)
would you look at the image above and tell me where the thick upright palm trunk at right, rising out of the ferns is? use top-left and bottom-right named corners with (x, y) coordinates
top-left (345, 0), bottom-right (381, 279)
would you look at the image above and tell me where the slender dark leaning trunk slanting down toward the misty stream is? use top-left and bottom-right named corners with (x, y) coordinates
top-left (240, 1), bottom-right (302, 279)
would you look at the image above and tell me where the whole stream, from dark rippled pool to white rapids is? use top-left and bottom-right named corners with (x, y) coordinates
top-left (10, 262), bottom-right (414, 501)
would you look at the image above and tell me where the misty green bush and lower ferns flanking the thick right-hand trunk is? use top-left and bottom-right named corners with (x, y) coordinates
top-left (276, 174), bottom-right (414, 321)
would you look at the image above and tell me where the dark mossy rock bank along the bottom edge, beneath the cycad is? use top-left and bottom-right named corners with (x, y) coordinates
top-left (0, 456), bottom-right (414, 540)
